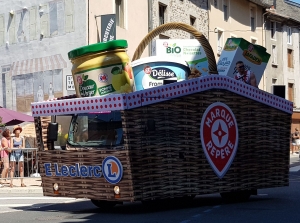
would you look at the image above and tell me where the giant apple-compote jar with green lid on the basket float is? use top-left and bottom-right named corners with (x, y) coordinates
top-left (68, 40), bottom-right (134, 97)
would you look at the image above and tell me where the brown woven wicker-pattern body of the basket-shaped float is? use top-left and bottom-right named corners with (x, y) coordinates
top-left (36, 90), bottom-right (291, 201)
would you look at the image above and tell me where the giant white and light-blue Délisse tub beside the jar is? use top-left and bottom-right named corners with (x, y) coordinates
top-left (132, 56), bottom-right (190, 91)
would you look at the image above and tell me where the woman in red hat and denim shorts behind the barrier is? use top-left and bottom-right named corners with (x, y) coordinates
top-left (10, 125), bottom-right (26, 187)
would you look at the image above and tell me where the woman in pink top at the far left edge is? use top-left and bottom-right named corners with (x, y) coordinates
top-left (0, 128), bottom-right (11, 187)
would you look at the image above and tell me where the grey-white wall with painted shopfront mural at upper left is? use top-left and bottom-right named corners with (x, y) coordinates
top-left (0, 0), bottom-right (87, 113)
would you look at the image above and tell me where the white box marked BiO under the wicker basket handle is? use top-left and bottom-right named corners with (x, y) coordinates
top-left (152, 39), bottom-right (209, 77)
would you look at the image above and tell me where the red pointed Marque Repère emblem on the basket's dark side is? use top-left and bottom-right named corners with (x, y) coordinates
top-left (200, 102), bottom-right (239, 178)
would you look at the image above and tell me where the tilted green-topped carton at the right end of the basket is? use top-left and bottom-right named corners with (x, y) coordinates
top-left (218, 38), bottom-right (270, 87)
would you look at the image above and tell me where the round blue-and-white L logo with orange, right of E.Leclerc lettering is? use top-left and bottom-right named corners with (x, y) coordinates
top-left (102, 156), bottom-right (123, 184)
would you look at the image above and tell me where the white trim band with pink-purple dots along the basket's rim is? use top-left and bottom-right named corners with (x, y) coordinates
top-left (31, 75), bottom-right (293, 117)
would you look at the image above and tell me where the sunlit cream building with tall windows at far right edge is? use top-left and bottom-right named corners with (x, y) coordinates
top-left (265, 0), bottom-right (300, 131)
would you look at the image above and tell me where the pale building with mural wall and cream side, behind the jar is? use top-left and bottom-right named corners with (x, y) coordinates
top-left (0, 0), bottom-right (149, 114)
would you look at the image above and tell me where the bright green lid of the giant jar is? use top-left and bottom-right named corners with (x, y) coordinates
top-left (68, 39), bottom-right (128, 59)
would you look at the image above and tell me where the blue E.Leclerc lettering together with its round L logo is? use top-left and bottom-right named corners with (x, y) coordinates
top-left (44, 156), bottom-right (123, 184)
